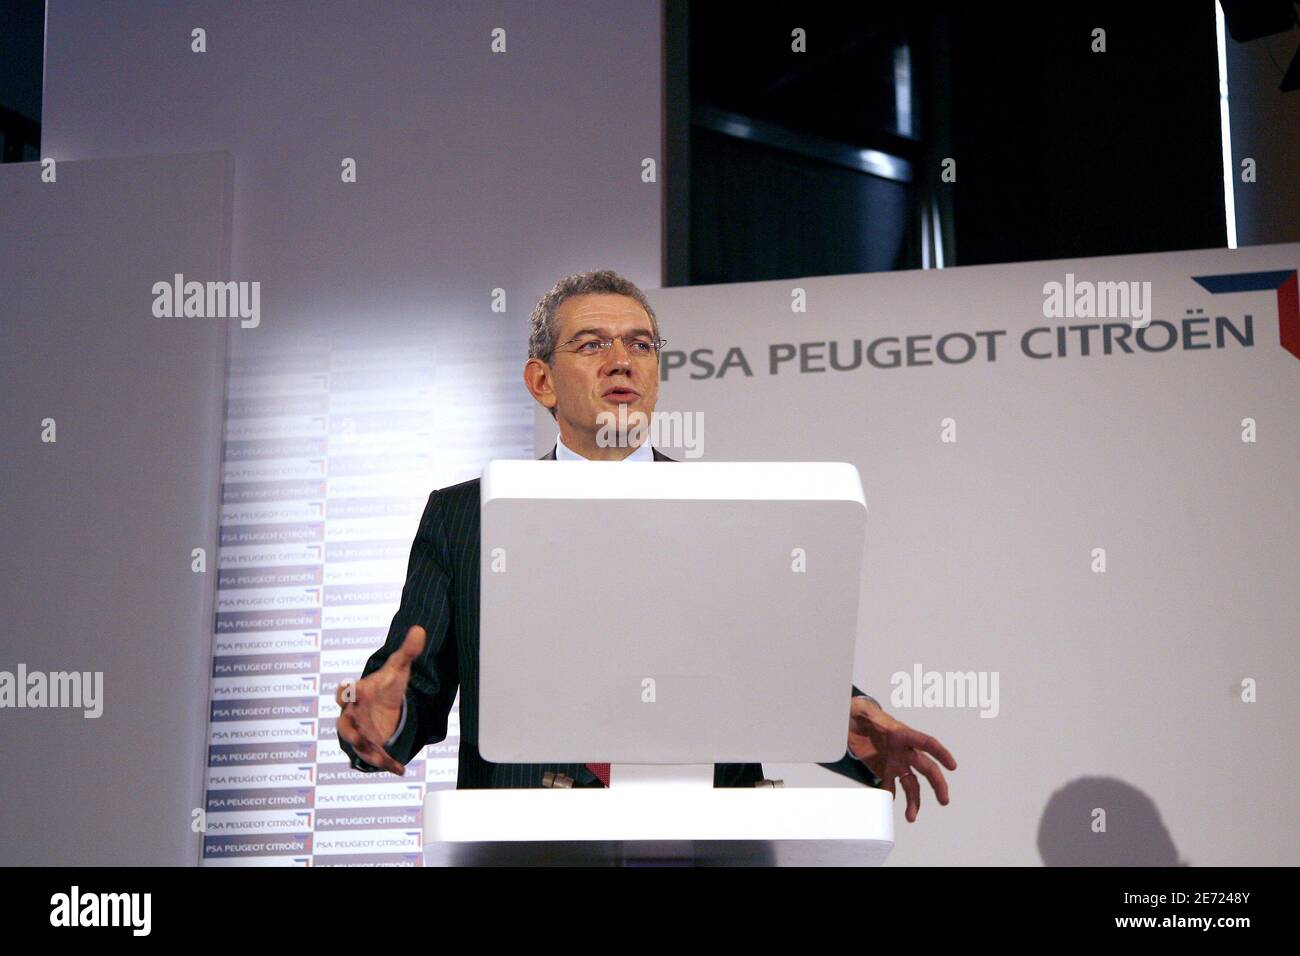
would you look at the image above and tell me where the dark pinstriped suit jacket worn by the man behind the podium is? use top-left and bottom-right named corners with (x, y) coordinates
top-left (338, 449), bottom-right (879, 790)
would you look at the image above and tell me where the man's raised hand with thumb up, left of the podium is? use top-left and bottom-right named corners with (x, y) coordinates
top-left (334, 624), bottom-right (425, 777)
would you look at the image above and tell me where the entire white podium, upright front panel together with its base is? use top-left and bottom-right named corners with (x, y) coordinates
top-left (441, 460), bottom-right (893, 865)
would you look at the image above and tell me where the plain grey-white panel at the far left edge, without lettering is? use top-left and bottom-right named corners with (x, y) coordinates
top-left (0, 152), bottom-right (238, 866)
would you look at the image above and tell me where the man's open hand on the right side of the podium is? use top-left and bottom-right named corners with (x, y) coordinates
top-left (849, 697), bottom-right (957, 823)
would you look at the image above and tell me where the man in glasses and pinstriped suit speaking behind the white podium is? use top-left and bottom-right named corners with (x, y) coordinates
top-left (335, 271), bottom-right (957, 822)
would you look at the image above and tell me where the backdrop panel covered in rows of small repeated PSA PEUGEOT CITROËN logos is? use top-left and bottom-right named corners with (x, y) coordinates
top-left (203, 339), bottom-right (532, 866)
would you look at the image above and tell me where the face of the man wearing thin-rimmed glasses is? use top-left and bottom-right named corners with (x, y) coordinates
top-left (534, 294), bottom-right (659, 436)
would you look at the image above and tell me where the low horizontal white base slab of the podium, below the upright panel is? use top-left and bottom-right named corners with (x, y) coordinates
top-left (424, 765), bottom-right (893, 866)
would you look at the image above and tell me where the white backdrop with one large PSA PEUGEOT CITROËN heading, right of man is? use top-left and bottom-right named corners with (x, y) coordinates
top-left (538, 245), bottom-right (1300, 865)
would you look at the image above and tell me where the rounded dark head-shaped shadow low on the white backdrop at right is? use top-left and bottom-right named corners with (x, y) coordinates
top-left (1039, 777), bottom-right (1188, 866)
